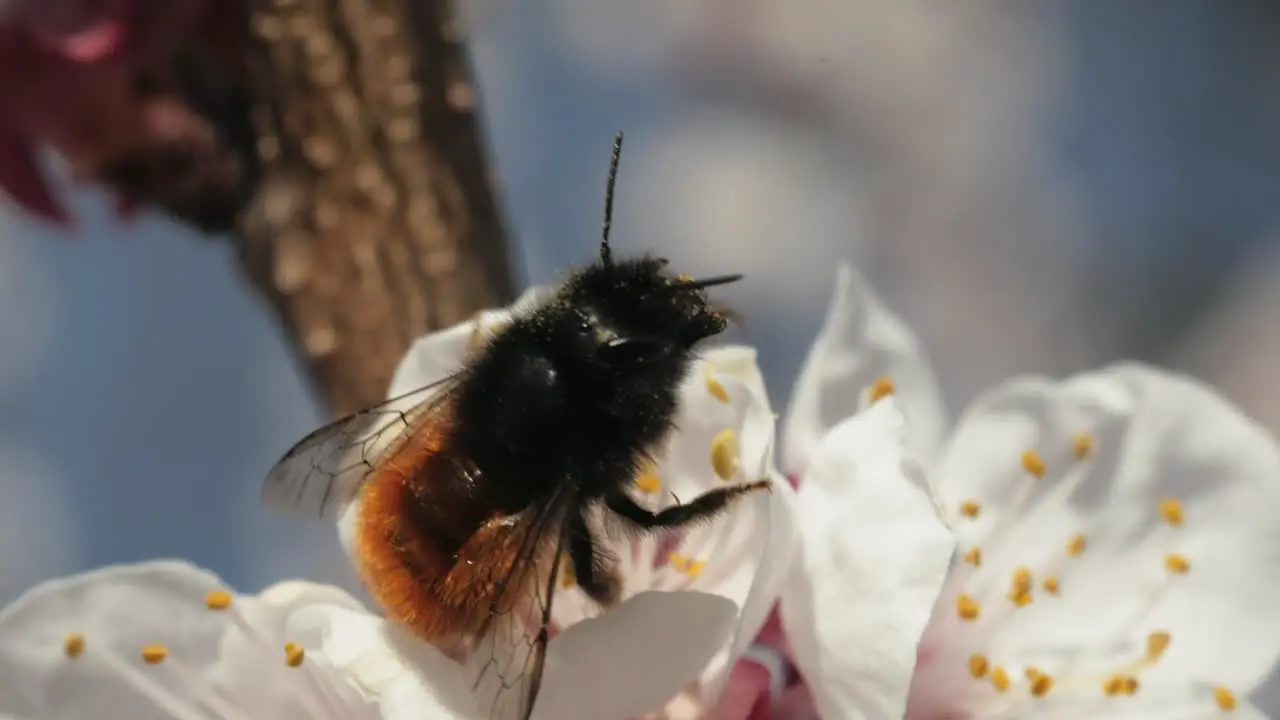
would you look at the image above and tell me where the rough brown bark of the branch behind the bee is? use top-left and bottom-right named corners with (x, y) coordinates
top-left (238, 0), bottom-right (512, 414)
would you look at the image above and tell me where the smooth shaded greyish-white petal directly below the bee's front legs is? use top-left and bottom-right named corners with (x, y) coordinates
top-left (534, 592), bottom-right (737, 720)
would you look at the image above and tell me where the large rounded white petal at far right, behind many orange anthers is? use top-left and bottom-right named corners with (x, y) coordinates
top-left (936, 365), bottom-right (1280, 688)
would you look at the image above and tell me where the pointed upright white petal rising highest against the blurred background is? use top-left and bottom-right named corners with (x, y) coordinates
top-left (782, 265), bottom-right (947, 473)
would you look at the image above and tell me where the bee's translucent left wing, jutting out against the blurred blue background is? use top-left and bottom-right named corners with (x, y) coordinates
top-left (260, 378), bottom-right (453, 520)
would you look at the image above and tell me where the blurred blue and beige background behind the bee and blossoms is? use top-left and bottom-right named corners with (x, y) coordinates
top-left (0, 0), bottom-right (1280, 681)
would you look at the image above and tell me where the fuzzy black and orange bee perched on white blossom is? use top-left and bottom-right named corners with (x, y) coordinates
top-left (254, 133), bottom-right (768, 719)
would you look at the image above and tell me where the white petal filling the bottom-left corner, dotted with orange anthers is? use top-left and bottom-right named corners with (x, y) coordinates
top-left (0, 561), bottom-right (370, 719)
